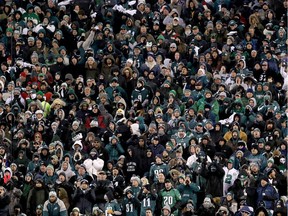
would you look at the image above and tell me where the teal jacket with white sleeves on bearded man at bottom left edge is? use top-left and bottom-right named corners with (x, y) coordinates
top-left (43, 198), bottom-right (68, 216)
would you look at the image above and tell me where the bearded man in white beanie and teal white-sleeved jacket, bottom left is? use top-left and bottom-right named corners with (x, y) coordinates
top-left (43, 191), bottom-right (68, 216)
